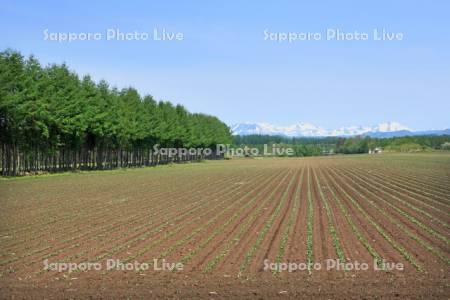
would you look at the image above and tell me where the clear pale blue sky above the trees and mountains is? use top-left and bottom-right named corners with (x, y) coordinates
top-left (0, 0), bottom-right (450, 130)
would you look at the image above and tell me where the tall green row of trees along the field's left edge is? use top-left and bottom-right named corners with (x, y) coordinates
top-left (0, 50), bottom-right (231, 175)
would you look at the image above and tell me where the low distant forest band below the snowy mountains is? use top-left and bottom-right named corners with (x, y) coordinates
top-left (233, 135), bottom-right (450, 156)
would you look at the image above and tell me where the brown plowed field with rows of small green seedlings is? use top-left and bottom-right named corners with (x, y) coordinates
top-left (0, 154), bottom-right (450, 299)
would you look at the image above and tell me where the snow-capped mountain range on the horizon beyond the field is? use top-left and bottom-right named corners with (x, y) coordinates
top-left (231, 122), bottom-right (450, 138)
